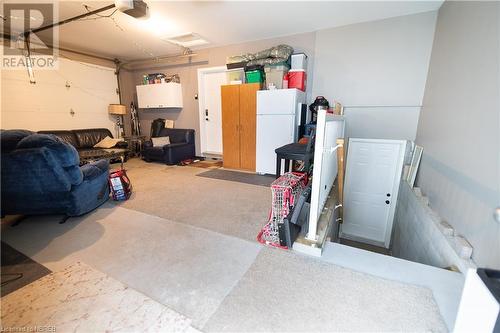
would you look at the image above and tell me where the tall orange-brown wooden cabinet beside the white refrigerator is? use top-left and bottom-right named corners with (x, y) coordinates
top-left (221, 83), bottom-right (260, 171)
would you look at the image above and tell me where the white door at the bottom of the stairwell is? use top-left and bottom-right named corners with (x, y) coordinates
top-left (341, 139), bottom-right (405, 248)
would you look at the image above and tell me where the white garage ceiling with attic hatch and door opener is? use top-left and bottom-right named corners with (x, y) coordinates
top-left (2, 0), bottom-right (442, 60)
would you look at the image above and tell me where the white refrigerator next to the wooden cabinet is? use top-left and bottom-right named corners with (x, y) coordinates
top-left (256, 89), bottom-right (306, 174)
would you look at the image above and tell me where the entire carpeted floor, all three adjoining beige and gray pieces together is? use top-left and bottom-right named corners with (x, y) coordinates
top-left (2, 159), bottom-right (445, 331)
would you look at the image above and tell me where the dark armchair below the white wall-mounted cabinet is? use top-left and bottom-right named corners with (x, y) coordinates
top-left (142, 128), bottom-right (196, 165)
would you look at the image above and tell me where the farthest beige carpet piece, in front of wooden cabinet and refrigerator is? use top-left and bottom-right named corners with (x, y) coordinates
top-left (117, 159), bottom-right (271, 241)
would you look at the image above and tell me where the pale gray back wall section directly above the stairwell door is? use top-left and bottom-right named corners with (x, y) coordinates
top-left (312, 12), bottom-right (436, 140)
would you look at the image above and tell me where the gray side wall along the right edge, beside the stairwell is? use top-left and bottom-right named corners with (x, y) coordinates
top-left (416, 1), bottom-right (500, 268)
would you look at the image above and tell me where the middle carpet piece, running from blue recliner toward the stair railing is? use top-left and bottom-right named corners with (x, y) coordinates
top-left (2, 203), bottom-right (261, 327)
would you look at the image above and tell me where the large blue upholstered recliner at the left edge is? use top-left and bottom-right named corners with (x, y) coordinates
top-left (0, 130), bottom-right (109, 216)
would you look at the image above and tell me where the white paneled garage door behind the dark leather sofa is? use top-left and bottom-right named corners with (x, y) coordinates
top-left (1, 58), bottom-right (119, 134)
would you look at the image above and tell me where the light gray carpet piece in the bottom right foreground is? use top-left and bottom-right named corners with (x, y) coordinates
top-left (202, 248), bottom-right (447, 332)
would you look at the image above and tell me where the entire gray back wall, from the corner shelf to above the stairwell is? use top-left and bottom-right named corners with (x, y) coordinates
top-left (122, 12), bottom-right (436, 154)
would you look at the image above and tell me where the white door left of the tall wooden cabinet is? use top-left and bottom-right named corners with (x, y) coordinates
top-left (200, 71), bottom-right (227, 154)
